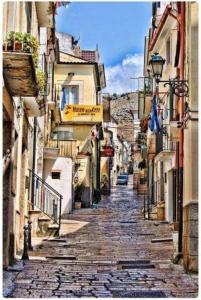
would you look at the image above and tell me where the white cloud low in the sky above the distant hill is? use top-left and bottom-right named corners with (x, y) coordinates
top-left (104, 54), bottom-right (144, 94)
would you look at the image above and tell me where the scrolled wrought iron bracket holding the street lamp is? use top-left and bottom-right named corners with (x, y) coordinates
top-left (157, 78), bottom-right (189, 97)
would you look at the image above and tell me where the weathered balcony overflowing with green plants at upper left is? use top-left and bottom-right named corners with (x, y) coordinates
top-left (3, 31), bottom-right (47, 97)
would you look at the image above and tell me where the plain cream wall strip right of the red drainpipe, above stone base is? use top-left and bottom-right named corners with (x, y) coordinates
top-left (183, 2), bottom-right (199, 206)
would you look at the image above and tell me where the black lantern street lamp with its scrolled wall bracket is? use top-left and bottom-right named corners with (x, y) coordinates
top-left (149, 53), bottom-right (189, 97)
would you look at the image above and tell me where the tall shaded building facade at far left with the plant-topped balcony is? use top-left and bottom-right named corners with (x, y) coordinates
top-left (3, 2), bottom-right (55, 267)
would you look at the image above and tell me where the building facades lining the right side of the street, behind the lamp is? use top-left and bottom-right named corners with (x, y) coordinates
top-left (139, 2), bottom-right (198, 271)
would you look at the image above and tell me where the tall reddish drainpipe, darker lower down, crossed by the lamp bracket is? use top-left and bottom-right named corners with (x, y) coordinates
top-left (178, 2), bottom-right (185, 257)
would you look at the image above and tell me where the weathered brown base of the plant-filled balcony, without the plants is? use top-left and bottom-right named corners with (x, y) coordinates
top-left (3, 51), bottom-right (39, 97)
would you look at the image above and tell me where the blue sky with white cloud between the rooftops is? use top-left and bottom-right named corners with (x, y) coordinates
top-left (56, 1), bottom-right (151, 93)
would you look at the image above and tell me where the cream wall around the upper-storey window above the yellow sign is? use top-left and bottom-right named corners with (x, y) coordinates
top-left (55, 65), bottom-right (96, 105)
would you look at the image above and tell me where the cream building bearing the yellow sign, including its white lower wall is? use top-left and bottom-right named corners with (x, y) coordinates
top-left (44, 33), bottom-right (105, 211)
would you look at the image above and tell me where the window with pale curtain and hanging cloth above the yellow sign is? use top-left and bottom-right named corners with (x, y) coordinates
top-left (61, 85), bottom-right (79, 110)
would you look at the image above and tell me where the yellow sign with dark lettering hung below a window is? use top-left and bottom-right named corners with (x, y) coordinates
top-left (63, 104), bottom-right (103, 123)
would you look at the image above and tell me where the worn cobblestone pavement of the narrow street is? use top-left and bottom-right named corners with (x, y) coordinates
top-left (4, 178), bottom-right (198, 298)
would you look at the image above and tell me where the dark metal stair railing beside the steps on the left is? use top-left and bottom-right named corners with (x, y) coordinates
top-left (29, 170), bottom-right (63, 229)
